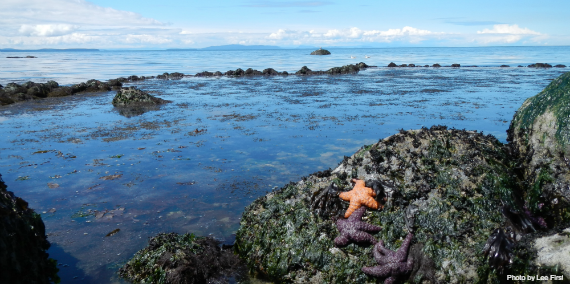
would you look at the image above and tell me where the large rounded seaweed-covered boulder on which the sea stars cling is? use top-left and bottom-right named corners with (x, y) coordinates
top-left (235, 127), bottom-right (519, 283)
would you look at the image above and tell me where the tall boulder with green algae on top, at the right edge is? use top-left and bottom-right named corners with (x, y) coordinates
top-left (507, 72), bottom-right (570, 229)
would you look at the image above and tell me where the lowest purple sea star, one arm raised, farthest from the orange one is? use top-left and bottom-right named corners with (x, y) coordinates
top-left (362, 233), bottom-right (414, 284)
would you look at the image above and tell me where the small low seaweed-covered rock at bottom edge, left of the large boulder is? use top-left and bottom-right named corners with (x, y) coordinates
top-left (119, 233), bottom-right (247, 284)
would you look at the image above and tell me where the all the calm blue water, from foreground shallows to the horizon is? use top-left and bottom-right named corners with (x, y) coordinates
top-left (0, 48), bottom-right (570, 283)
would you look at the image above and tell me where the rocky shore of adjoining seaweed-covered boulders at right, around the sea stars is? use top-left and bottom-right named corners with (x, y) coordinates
top-left (230, 70), bottom-right (570, 283)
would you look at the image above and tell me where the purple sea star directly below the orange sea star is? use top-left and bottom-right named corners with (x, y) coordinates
top-left (334, 207), bottom-right (382, 247)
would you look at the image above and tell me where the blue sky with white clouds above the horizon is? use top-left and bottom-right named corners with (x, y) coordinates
top-left (0, 0), bottom-right (570, 49)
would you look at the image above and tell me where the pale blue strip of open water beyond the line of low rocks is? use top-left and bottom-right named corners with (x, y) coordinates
top-left (0, 46), bottom-right (570, 85)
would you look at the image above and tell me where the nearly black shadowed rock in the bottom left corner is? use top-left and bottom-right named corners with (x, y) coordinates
top-left (0, 175), bottom-right (59, 284)
